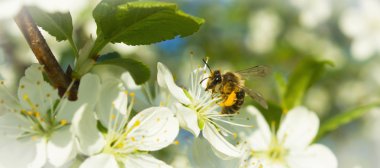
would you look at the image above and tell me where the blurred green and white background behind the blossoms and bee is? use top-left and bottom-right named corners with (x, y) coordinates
top-left (0, 0), bottom-right (380, 168)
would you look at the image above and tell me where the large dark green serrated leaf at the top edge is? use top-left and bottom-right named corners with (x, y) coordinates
top-left (91, 0), bottom-right (204, 55)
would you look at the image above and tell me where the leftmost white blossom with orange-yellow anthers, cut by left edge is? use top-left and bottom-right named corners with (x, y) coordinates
top-left (0, 64), bottom-right (96, 167)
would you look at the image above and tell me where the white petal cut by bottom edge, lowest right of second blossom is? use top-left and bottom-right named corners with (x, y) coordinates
top-left (124, 154), bottom-right (171, 168)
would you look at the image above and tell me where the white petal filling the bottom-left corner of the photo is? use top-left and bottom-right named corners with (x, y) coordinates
top-left (0, 136), bottom-right (36, 168)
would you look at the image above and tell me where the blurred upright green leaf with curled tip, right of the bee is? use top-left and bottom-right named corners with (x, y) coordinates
top-left (282, 59), bottom-right (332, 111)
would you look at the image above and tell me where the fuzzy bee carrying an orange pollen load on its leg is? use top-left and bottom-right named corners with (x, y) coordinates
top-left (201, 59), bottom-right (270, 114)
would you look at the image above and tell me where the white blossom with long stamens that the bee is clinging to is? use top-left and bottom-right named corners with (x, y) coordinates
top-left (157, 63), bottom-right (246, 159)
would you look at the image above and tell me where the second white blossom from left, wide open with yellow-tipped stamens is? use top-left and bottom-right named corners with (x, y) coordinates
top-left (73, 79), bottom-right (179, 168)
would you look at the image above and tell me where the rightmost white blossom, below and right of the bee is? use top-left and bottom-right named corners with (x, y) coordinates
top-left (240, 106), bottom-right (337, 168)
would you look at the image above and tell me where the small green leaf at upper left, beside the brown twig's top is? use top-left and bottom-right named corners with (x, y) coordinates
top-left (29, 7), bottom-right (73, 41)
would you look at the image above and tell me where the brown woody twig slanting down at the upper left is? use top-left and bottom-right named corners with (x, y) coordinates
top-left (14, 7), bottom-right (76, 99)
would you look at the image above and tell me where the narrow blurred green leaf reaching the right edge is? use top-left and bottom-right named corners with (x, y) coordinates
top-left (314, 102), bottom-right (380, 142)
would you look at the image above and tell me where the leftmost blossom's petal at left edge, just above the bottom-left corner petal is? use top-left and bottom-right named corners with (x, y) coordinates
top-left (0, 112), bottom-right (30, 139)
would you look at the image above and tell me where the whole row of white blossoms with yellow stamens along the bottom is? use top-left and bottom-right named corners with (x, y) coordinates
top-left (0, 63), bottom-right (337, 168)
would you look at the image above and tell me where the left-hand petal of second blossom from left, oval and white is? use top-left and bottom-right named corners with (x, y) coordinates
top-left (71, 105), bottom-right (105, 155)
